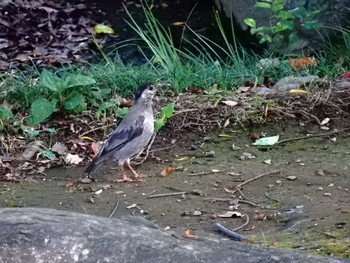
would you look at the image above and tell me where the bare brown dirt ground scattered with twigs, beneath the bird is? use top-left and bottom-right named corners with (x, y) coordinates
top-left (0, 125), bottom-right (350, 257)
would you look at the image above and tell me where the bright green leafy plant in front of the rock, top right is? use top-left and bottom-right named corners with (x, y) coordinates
top-left (244, 0), bottom-right (320, 48)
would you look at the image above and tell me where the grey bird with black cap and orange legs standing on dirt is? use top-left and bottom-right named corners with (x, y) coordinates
top-left (84, 83), bottom-right (167, 182)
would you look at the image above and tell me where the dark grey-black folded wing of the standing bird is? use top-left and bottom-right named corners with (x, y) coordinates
top-left (96, 116), bottom-right (145, 159)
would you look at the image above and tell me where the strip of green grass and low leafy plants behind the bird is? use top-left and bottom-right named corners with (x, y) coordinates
top-left (0, 2), bottom-right (350, 127)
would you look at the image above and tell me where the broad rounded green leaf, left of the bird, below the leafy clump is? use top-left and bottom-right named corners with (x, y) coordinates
top-left (28, 98), bottom-right (56, 126)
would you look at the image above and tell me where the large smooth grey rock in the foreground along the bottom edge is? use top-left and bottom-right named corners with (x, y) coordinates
top-left (0, 208), bottom-right (350, 263)
